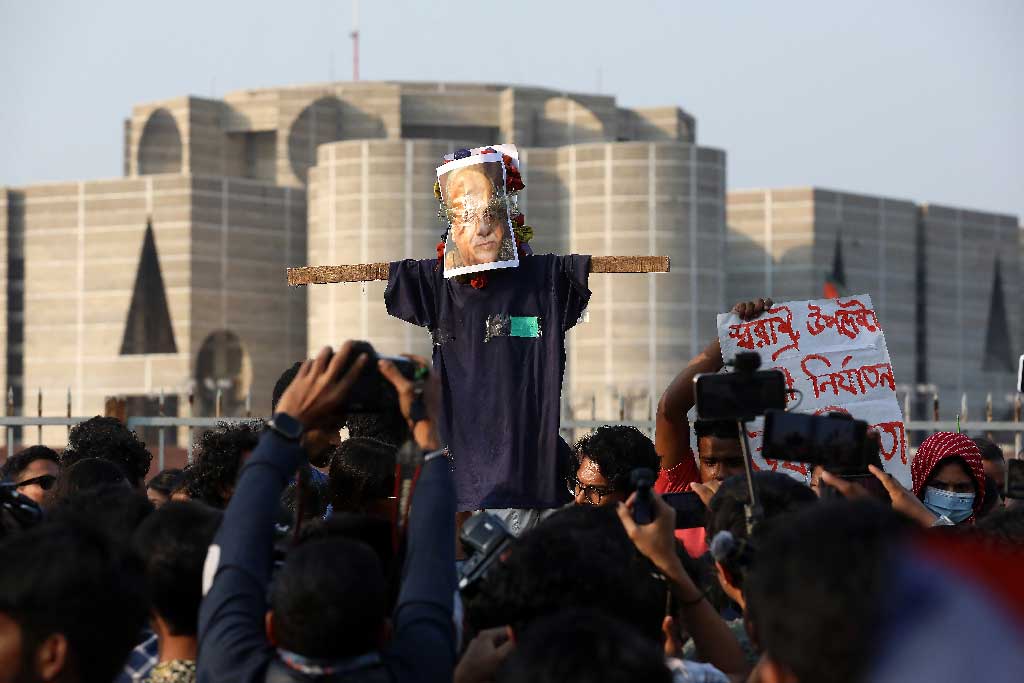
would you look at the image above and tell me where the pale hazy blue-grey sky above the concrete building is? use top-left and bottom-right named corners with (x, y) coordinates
top-left (0, 0), bottom-right (1024, 216)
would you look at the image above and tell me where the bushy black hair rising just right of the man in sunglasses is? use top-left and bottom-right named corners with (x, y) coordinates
top-left (60, 415), bottom-right (153, 489)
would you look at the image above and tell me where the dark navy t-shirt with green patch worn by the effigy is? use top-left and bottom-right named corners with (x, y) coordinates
top-left (384, 254), bottom-right (590, 510)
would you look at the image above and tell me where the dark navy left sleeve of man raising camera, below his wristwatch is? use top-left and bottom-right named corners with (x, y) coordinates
top-left (197, 432), bottom-right (299, 683)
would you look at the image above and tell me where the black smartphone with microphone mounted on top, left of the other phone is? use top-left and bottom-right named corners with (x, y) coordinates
top-left (694, 370), bottom-right (785, 421)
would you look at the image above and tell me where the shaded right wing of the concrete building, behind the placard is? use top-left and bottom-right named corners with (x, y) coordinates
top-left (725, 187), bottom-right (1024, 419)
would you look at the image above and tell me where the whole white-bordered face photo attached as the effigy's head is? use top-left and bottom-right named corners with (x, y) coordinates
top-left (439, 157), bottom-right (516, 275)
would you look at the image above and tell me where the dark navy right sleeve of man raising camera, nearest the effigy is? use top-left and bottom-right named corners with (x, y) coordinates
top-left (386, 458), bottom-right (456, 682)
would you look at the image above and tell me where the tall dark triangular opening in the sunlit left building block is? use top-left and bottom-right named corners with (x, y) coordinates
top-left (121, 220), bottom-right (178, 355)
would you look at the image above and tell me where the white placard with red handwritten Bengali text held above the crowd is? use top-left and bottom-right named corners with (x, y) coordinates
top-left (718, 294), bottom-right (910, 485)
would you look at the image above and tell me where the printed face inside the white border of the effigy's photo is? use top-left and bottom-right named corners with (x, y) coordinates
top-left (444, 166), bottom-right (509, 269)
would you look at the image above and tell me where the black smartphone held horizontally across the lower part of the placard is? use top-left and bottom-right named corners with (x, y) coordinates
top-left (761, 410), bottom-right (879, 476)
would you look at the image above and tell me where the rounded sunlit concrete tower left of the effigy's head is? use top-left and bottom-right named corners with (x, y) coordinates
top-left (307, 140), bottom-right (454, 356)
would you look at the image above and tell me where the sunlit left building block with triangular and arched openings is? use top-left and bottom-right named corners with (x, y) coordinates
top-left (4, 174), bottom-right (306, 443)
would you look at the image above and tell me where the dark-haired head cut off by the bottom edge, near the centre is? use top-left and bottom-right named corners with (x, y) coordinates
top-left (497, 608), bottom-right (671, 683)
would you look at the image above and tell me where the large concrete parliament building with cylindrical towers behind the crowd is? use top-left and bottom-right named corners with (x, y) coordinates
top-left (0, 82), bottom-right (1024, 444)
